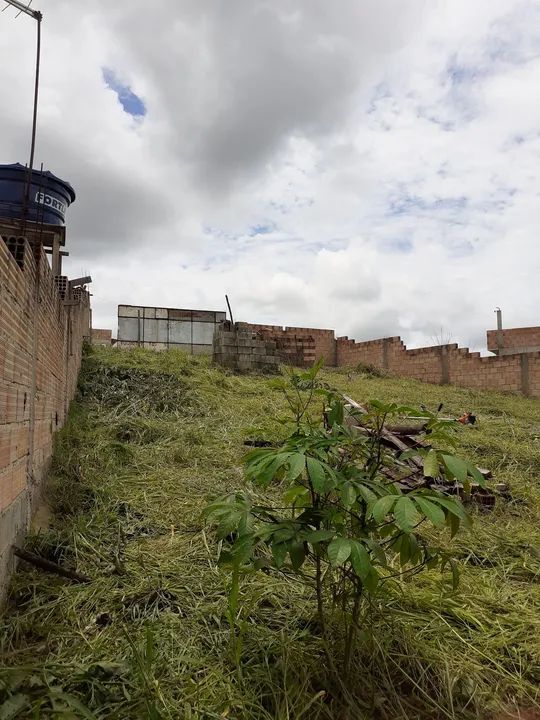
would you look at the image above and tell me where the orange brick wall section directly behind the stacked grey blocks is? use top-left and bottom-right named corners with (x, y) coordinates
top-left (241, 323), bottom-right (336, 367)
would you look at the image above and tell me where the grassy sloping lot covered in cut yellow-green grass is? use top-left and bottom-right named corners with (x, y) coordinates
top-left (0, 350), bottom-right (540, 720)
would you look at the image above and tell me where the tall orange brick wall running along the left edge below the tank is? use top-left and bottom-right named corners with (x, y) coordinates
top-left (0, 238), bottom-right (90, 601)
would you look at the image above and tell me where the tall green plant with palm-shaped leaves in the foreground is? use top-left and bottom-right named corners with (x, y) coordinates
top-left (205, 365), bottom-right (483, 677)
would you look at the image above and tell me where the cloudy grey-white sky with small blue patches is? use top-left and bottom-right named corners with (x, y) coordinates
top-left (0, 0), bottom-right (540, 349)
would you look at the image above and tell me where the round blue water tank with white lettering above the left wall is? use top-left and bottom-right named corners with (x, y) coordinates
top-left (0, 163), bottom-right (75, 225)
